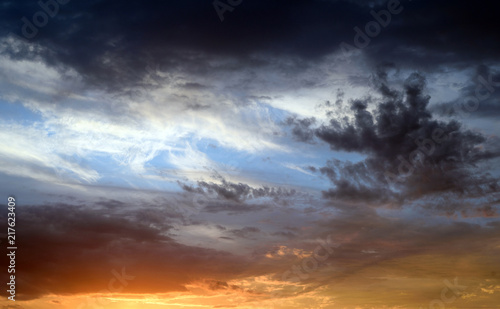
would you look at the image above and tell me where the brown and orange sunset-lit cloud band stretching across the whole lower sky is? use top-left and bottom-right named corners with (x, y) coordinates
top-left (0, 194), bottom-right (500, 300)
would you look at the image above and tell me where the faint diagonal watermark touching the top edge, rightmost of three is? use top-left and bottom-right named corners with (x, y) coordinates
top-left (340, 0), bottom-right (411, 63)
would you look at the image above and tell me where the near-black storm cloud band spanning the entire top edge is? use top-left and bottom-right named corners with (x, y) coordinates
top-left (0, 0), bottom-right (500, 91)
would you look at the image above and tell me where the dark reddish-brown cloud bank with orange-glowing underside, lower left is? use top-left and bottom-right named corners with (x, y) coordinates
top-left (1, 204), bottom-right (253, 300)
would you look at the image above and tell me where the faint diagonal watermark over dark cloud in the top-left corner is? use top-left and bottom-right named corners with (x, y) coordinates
top-left (21, 0), bottom-right (71, 40)
